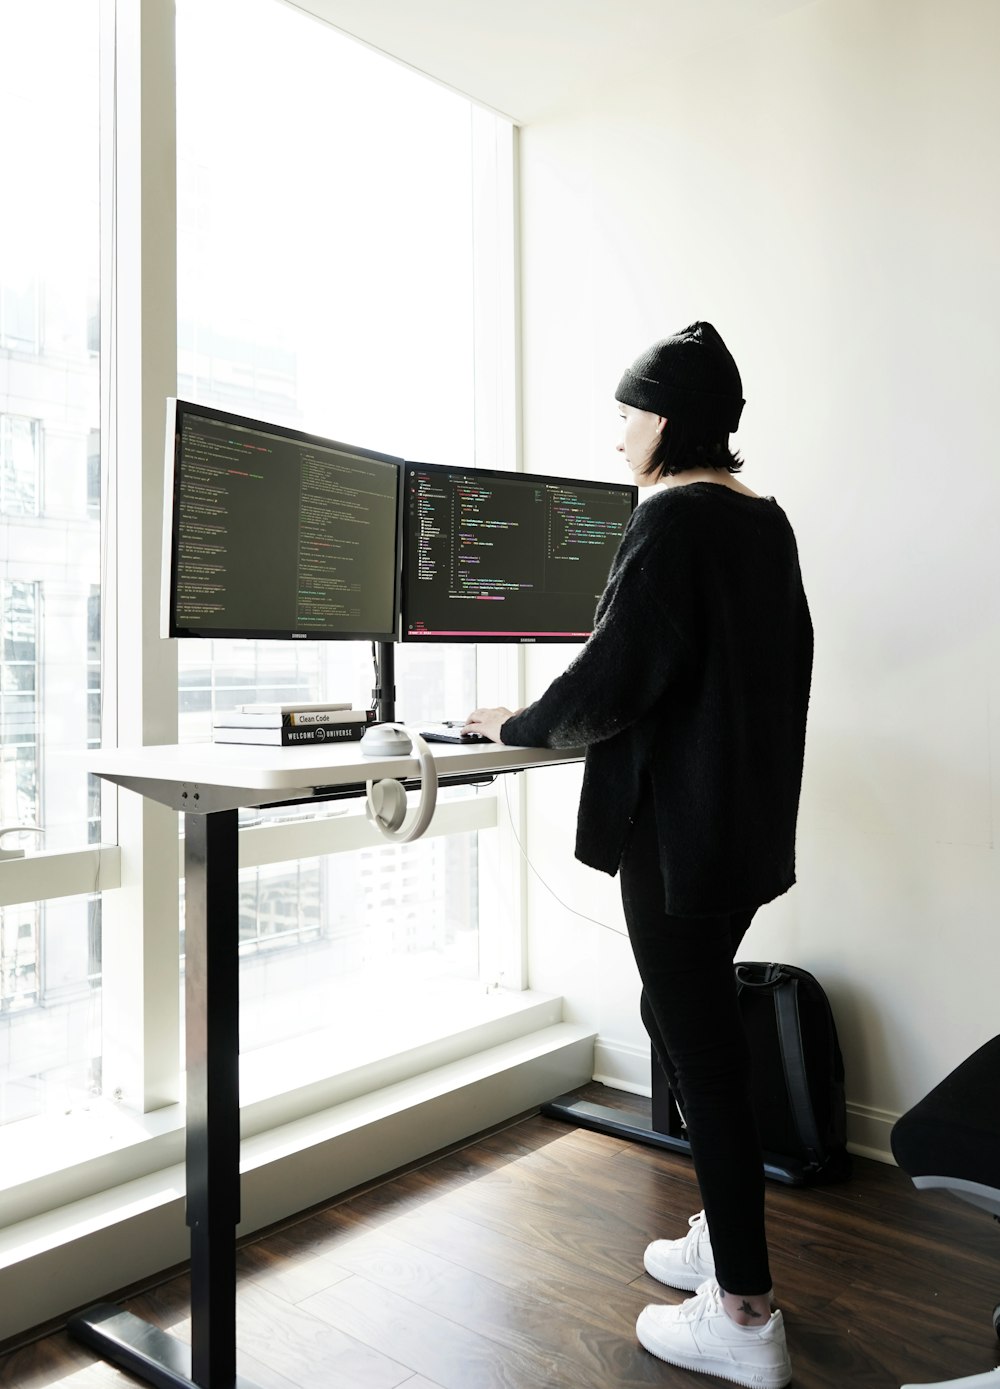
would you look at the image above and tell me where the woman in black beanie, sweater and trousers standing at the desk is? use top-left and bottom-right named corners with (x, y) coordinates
top-left (465, 322), bottom-right (813, 1389)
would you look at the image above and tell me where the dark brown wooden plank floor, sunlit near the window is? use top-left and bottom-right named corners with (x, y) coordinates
top-left (0, 1086), bottom-right (1000, 1389)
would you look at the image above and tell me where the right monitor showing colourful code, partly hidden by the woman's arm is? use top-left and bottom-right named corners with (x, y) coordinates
top-left (400, 461), bottom-right (638, 643)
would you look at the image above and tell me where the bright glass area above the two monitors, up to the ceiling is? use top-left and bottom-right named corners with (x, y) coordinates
top-left (176, 0), bottom-right (474, 463)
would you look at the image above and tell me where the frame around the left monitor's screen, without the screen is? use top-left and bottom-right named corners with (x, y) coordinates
top-left (160, 396), bottom-right (404, 642)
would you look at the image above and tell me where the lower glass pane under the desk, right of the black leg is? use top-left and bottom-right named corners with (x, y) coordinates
top-left (240, 835), bottom-right (479, 1064)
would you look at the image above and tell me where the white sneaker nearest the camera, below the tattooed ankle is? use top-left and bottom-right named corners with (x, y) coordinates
top-left (636, 1278), bottom-right (792, 1389)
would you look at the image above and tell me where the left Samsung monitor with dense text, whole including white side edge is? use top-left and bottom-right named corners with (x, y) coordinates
top-left (161, 400), bottom-right (403, 642)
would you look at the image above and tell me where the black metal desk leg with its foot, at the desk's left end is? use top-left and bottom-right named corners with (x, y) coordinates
top-left (69, 810), bottom-right (261, 1389)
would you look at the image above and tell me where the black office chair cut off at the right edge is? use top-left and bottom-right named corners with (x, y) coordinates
top-left (890, 1036), bottom-right (1000, 1389)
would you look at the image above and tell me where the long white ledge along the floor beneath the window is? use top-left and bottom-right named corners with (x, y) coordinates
top-left (0, 1022), bottom-right (593, 1340)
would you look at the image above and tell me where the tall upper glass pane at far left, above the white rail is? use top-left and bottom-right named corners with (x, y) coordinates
top-left (0, 0), bottom-right (101, 849)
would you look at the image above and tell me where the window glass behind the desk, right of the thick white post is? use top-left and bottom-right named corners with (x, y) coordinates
top-left (176, 0), bottom-right (510, 1051)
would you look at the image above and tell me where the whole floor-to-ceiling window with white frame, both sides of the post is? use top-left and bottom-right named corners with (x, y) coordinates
top-left (0, 0), bottom-right (517, 1122)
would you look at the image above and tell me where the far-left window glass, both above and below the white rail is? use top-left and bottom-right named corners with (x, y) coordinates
top-left (0, 0), bottom-right (101, 1122)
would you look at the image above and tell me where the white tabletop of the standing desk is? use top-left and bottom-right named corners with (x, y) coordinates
top-left (86, 742), bottom-right (583, 814)
